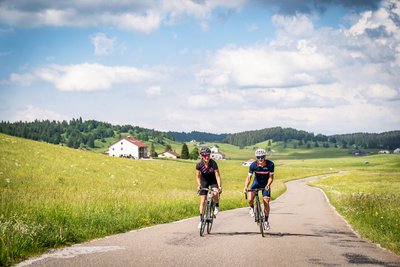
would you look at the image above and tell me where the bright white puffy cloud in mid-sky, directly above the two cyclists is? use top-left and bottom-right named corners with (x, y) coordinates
top-left (197, 45), bottom-right (333, 88)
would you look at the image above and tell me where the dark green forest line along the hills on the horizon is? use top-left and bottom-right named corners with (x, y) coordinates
top-left (0, 118), bottom-right (400, 150)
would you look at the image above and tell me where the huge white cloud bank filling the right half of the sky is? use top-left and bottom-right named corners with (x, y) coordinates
top-left (188, 1), bottom-right (400, 134)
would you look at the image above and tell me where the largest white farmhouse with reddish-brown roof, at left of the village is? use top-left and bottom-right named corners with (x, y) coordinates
top-left (108, 136), bottom-right (147, 159)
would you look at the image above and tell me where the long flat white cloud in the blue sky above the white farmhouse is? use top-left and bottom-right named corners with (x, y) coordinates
top-left (10, 63), bottom-right (162, 91)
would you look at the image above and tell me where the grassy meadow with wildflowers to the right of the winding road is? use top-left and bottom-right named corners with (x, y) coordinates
top-left (311, 155), bottom-right (400, 254)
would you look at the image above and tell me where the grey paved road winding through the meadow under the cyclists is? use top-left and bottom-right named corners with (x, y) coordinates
top-left (19, 177), bottom-right (400, 267)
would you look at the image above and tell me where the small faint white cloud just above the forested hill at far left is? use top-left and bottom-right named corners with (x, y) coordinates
top-left (12, 105), bottom-right (70, 121)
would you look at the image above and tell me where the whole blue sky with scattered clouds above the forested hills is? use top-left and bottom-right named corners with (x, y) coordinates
top-left (0, 0), bottom-right (400, 135)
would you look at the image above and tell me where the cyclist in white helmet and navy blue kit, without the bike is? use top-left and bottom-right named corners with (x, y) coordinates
top-left (243, 148), bottom-right (274, 231)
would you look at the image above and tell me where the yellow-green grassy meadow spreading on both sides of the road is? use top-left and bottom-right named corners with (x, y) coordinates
top-left (0, 134), bottom-right (400, 266)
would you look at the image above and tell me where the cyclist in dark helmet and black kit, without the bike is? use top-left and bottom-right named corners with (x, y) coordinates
top-left (196, 147), bottom-right (222, 228)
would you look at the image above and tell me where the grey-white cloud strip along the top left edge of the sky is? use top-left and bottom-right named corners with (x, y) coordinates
top-left (0, 0), bottom-right (246, 33)
